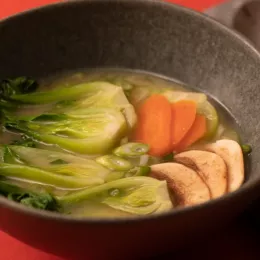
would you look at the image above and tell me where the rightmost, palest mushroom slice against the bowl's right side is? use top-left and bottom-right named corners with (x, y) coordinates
top-left (206, 140), bottom-right (245, 192)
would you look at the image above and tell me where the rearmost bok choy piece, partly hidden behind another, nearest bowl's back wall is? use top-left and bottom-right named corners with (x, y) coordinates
top-left (4, 82), bottom-right (137, 128)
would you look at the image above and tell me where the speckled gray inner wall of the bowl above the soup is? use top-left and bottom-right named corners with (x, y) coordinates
top-left (0, 0), bottom-right (260, 212)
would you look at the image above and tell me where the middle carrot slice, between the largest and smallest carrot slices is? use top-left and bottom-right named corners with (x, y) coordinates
top-left (172, 100), bottom-right (197, 148)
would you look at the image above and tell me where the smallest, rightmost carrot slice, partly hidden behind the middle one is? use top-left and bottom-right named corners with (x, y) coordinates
top-left (175, 115), bottom-right (207, 152)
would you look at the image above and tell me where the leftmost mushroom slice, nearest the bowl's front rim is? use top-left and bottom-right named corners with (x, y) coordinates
top-left (151, 163), bottom-right (210, 206)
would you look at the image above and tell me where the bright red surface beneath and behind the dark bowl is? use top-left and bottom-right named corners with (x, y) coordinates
top-left (0, 0), bottom-right (226, 260)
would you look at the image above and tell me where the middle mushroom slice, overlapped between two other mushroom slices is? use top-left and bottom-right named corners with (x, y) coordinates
top-left (174, 150), bottom-right (228, 198)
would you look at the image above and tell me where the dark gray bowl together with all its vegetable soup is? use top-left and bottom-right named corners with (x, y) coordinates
top-left (0, 0), bottom-right (260, 260)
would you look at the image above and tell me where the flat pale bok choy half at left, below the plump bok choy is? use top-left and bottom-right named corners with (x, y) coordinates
top-left (0, 145), bottom-right (110, 188)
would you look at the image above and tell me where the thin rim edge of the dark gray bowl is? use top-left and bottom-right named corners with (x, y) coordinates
top-left (0, 0), bottom-right (260, 225)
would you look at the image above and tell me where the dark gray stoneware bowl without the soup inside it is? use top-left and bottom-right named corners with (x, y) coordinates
top-left (0, 0), bottom-right (260, 260)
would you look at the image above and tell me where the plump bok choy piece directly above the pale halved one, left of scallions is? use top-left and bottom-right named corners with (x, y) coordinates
top-left (5, 107), bottom-right (127, 154)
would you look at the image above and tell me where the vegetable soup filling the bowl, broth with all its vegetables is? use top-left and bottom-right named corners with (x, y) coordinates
top-left (0, 69), bottom-right (251, 218)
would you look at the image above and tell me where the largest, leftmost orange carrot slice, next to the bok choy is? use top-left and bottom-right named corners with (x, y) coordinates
top-left (134, 94), bottom-right (172, 156)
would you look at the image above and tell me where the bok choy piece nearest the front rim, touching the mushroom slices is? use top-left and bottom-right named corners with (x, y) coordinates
top-left (58, 177), bottom-right (172, 215)
